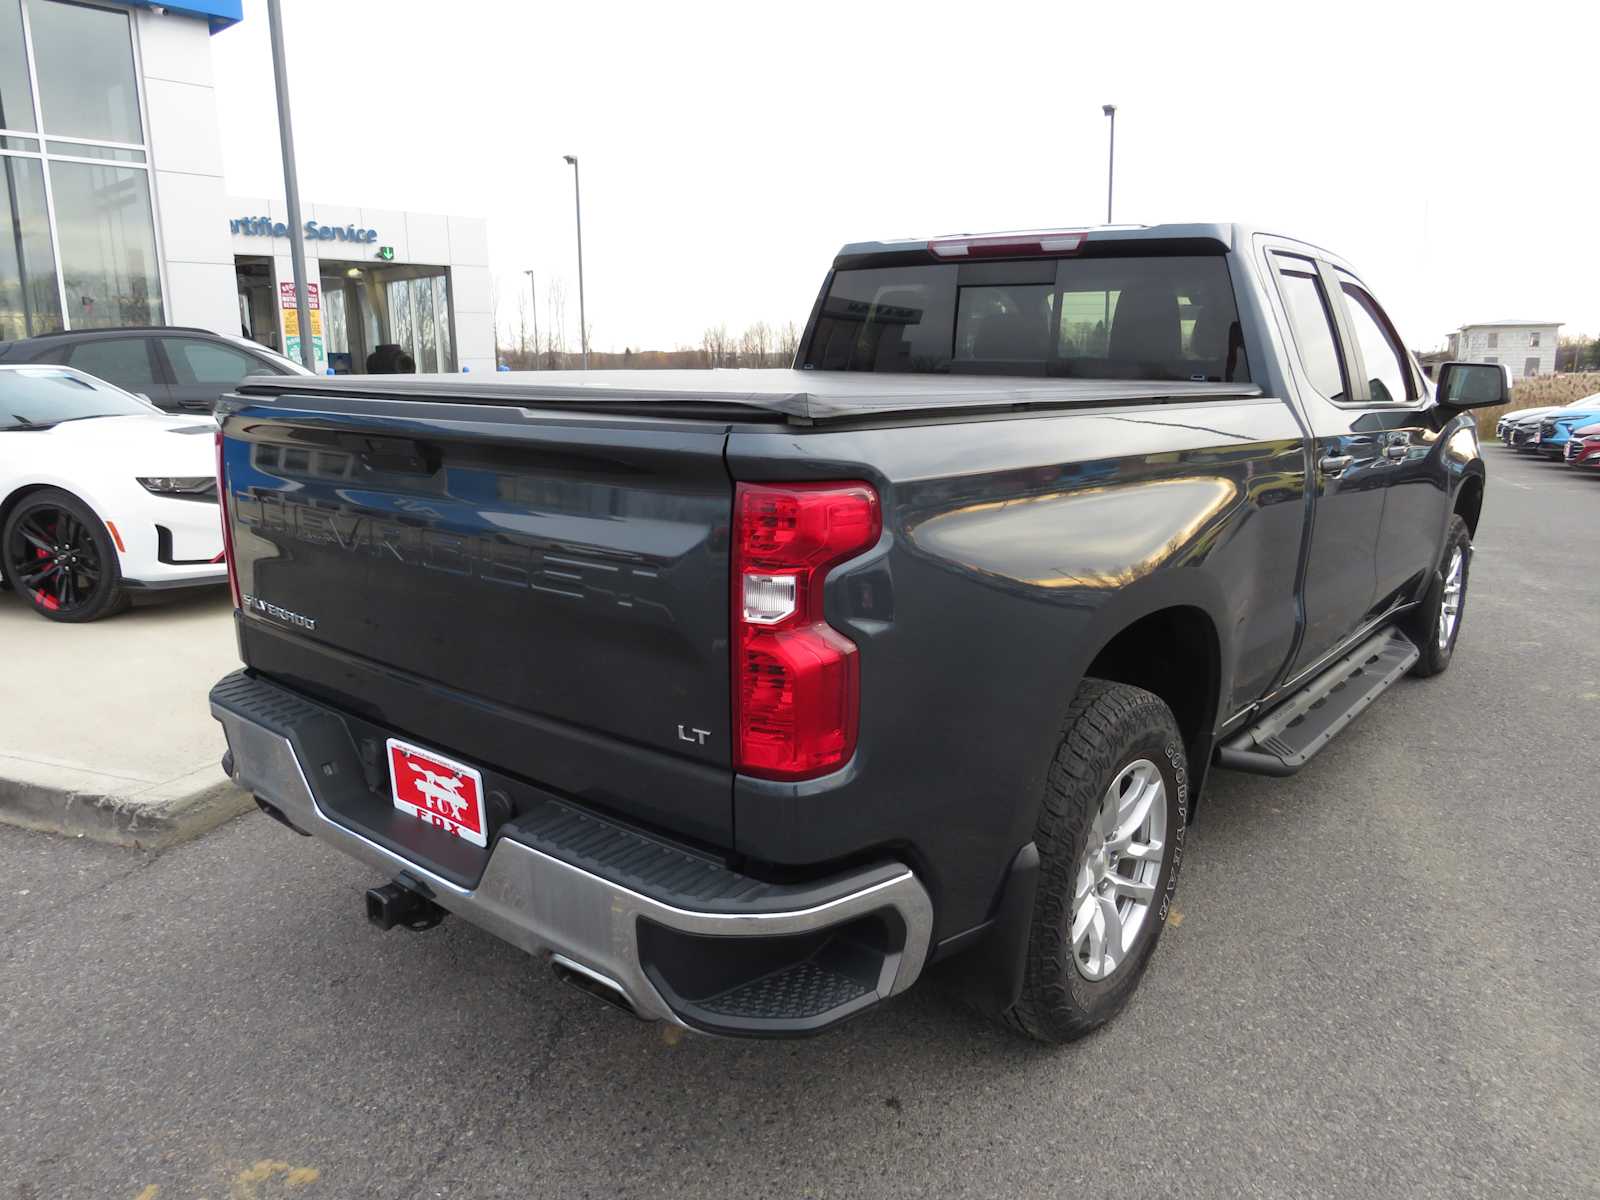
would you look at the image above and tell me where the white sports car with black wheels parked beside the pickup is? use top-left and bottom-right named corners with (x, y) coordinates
top-left (0, 365), bottom-right (227, 621)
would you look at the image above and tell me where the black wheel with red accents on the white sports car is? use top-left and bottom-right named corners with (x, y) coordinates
top-left (0, 488), bottom-right (128, 621)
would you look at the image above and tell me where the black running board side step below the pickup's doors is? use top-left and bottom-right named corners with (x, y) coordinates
top-left (1216, 629), bottom-right (1421, 774)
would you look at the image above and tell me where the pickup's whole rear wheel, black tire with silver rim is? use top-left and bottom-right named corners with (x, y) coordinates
top-left (1005, 680), bottom-right (1189, 1042)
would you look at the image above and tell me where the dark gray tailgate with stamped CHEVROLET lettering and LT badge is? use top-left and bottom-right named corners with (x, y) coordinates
top-left (222, 394), bottom-right (733, 845)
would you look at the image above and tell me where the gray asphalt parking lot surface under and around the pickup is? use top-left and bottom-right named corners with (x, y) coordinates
top-left (0, 446), bottom-right (1600, 1200)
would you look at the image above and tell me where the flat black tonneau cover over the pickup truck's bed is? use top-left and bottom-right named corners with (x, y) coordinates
top-left (237, 368), bottom-right (1261, 424)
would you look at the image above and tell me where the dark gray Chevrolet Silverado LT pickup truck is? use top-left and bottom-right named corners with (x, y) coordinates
top-left (211, 226), bottom-right (1506, 1040)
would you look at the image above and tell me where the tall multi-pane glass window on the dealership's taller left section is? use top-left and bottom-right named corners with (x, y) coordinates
top-left (0, 0), bottom-right (163, 338)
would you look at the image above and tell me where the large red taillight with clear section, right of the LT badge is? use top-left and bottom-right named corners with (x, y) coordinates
top-left (733, 483), bottom-right (883, 779)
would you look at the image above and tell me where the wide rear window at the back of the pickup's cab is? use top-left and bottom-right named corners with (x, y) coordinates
top-left (802, 254), bottom-right (1250, 382)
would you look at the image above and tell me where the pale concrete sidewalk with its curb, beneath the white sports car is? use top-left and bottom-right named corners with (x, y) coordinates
top-left (0, 589), bottom-right (251, 846)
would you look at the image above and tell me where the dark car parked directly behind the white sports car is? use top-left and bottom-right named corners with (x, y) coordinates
top-left (0, 325), bottom-right (310, 413)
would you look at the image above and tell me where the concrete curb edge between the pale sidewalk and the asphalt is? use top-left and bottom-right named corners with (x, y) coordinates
top-left (0, 766), bottom-right (254, 850)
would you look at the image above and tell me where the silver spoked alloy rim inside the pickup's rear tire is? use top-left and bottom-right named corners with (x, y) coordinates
top-left (1070, 758), bottom-right (1166, 981)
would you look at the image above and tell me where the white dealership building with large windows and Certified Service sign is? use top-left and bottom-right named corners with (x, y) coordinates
top-left (0, 0), bottom-right (494, 373)
